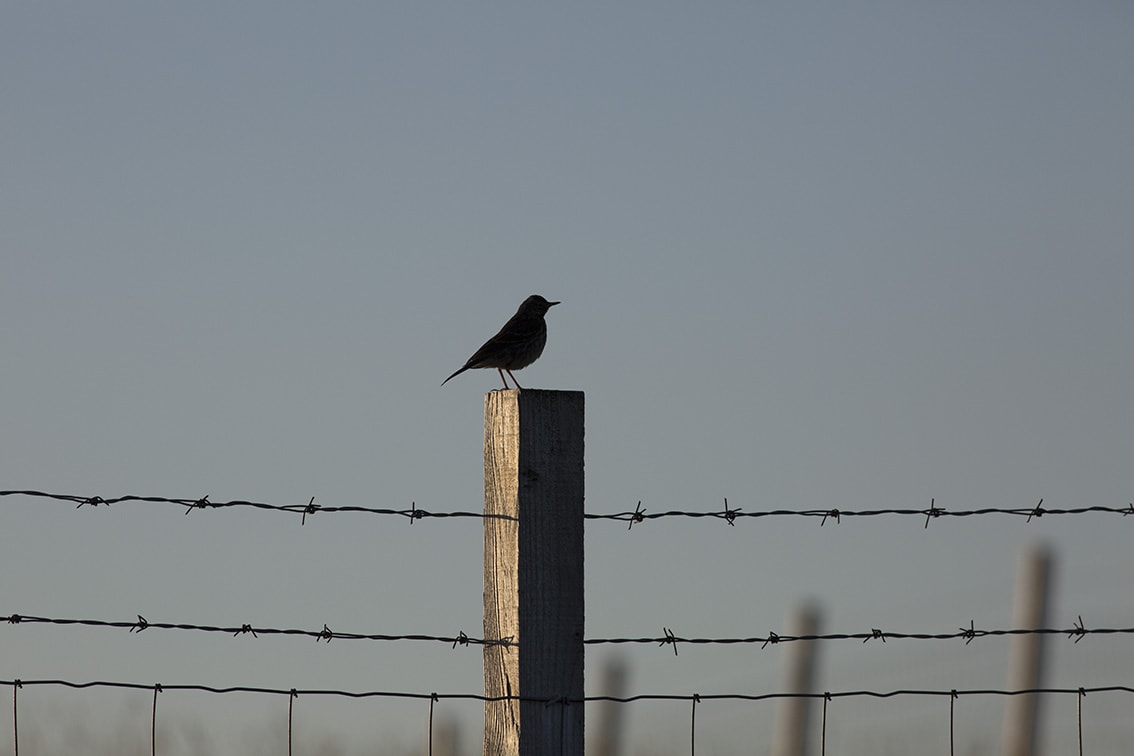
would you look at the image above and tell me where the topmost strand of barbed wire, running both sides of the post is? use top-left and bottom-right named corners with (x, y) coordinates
top-left (0, 491), bottom-right (1134, 529)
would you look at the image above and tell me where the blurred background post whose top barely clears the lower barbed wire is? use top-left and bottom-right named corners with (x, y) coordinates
top-left (772, 604), bottom-right (819, 756)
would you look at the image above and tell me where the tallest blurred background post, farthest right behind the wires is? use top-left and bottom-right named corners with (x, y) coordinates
top-left (1000, 546), bottom-right (1051, 756)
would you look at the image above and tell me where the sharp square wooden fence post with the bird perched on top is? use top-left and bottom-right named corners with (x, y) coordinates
top-left (484, 389), bottom-right (584, 756)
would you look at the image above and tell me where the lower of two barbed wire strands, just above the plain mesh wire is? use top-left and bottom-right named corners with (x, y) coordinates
top-left (0, 614), bottom-right (1134, 655)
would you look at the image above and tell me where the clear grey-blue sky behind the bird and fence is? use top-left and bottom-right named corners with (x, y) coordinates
top-left (0, 2), bottom-right (1134, 754)
